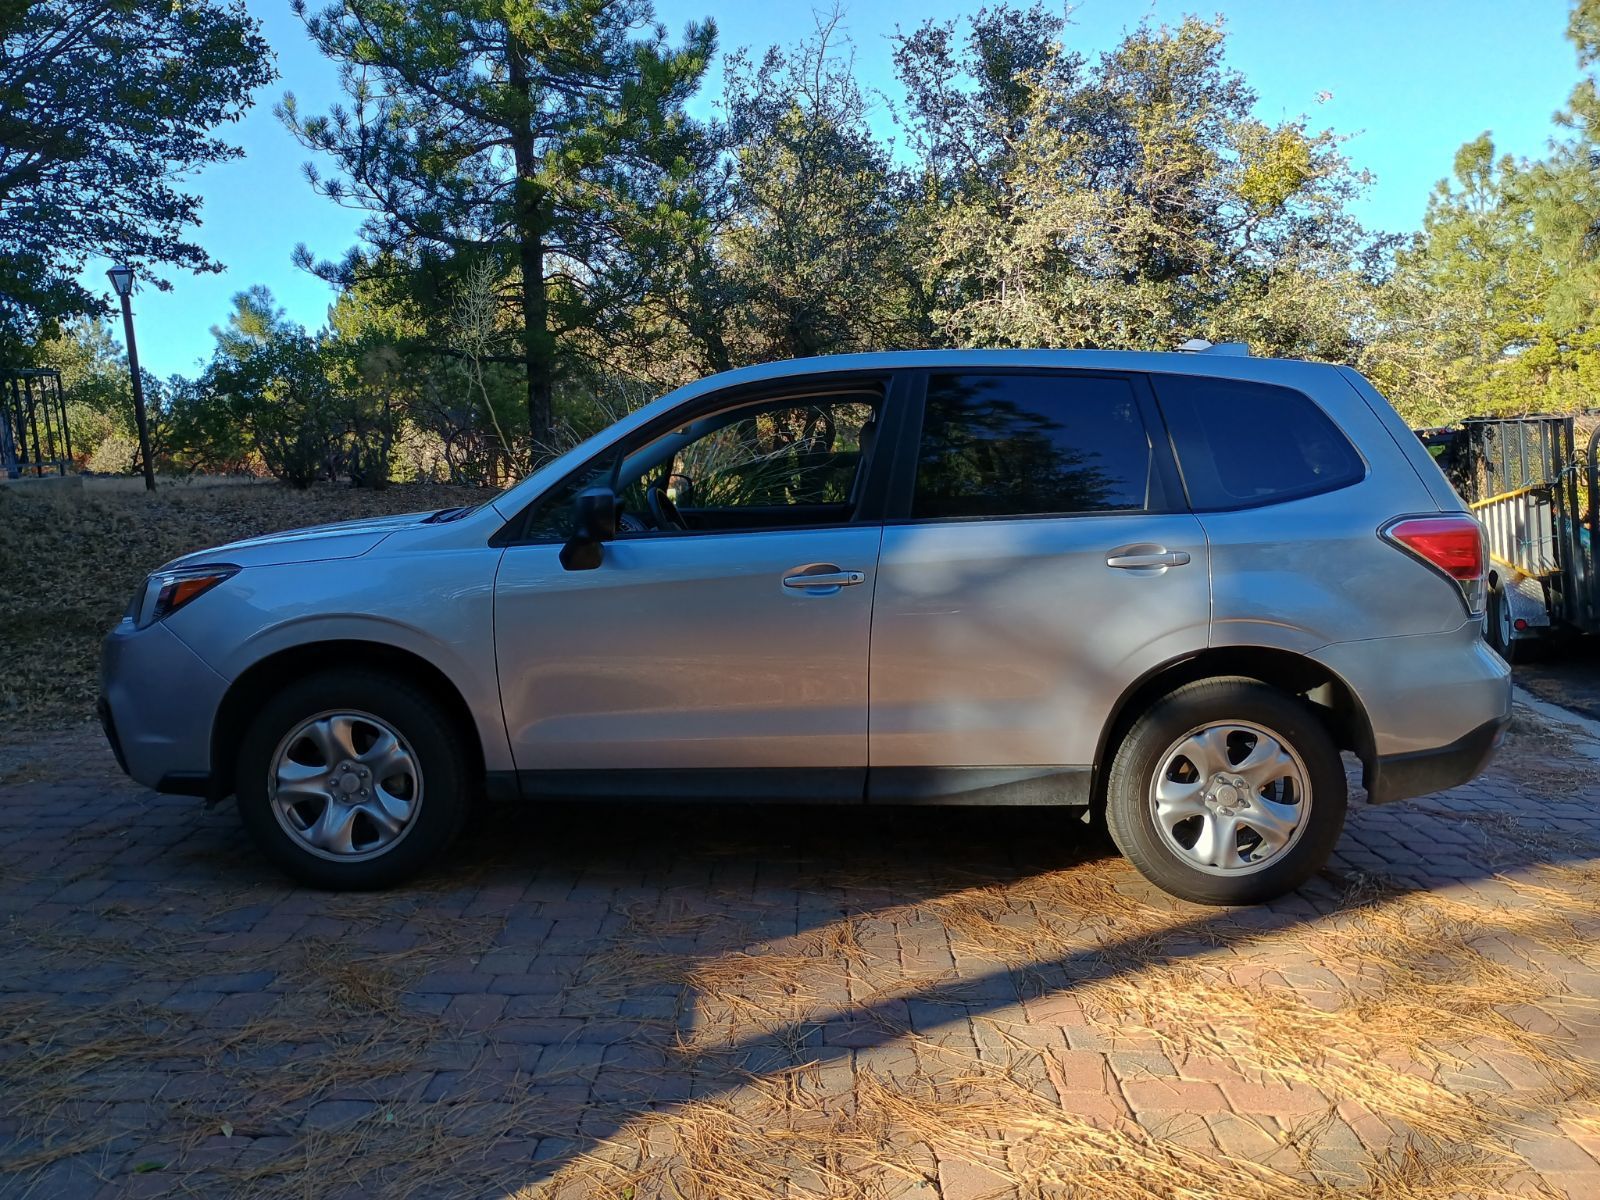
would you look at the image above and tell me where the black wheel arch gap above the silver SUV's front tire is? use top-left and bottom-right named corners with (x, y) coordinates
top-left (211, 638), bottom-right (485, 798)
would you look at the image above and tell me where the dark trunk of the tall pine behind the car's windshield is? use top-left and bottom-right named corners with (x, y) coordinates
top-left (507, 35), bottom-right (555, 451)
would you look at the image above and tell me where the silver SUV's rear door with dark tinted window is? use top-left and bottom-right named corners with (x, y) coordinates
top-left (869, 371), bottom-right (1210, 802)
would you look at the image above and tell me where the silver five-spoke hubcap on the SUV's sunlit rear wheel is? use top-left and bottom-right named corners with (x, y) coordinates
top-left (1150, 722), bottom-right (1310, 875)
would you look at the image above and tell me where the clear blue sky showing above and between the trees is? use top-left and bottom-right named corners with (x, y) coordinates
top-left (94, 0), bottom-right (1578, 376)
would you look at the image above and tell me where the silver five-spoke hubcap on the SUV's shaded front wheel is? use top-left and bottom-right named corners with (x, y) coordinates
top-left (267, 712), bottom-right (422, 862)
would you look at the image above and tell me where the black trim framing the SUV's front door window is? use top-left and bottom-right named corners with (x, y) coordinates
top-left (490, 368), bottom-right (907, 549)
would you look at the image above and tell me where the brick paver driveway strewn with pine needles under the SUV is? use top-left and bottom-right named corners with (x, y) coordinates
top-left (0, 714), bottom-right (1600, 1200)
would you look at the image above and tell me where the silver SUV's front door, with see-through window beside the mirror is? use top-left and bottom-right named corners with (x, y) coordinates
top-left (494, 387), bottom-right (883, 802)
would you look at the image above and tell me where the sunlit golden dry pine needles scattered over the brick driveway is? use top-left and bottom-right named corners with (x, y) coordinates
top-left (526, 829), bottom-right (1600, 1200)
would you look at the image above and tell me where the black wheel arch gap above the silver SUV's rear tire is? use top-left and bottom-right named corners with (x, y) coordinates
top-left (1091, 646), bottom-right (1378, 808)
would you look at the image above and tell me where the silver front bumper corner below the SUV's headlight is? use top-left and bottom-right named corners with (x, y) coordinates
top-left (98, 621), bottom-right (227, 795)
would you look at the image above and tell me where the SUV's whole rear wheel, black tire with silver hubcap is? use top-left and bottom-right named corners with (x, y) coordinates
top-left (1106, 678), bottom-right (1349, 904)
